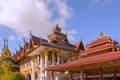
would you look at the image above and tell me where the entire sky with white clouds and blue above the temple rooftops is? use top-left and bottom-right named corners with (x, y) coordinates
top-left (0, 0), bottom-right (120, 52)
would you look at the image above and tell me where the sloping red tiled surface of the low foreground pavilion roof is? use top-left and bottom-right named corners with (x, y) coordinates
top-left (45, 51), bottom-right (120, 71)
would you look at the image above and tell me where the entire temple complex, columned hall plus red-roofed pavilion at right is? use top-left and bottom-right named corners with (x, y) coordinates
top-left (9, 24), bottom-right (120, 80)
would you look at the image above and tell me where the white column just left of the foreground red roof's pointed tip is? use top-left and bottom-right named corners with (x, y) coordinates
top-left (40, 51), bottom-right (44, 80)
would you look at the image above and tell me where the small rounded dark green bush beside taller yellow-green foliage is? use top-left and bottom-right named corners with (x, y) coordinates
top-left (9, 72), bottom-right (26, 80)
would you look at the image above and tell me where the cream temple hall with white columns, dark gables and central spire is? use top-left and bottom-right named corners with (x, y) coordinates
top-left (14, 24), bottom-right (84, 80)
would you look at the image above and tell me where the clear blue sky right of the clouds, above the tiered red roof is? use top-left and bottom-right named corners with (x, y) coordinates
top-left (69, 0), bottom-right (120, 43)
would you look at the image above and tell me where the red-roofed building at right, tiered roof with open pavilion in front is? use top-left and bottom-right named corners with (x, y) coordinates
top-left (45, 33), bottom-right (120, 80)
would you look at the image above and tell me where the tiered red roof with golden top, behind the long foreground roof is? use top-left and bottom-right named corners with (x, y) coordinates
top-left (81, 33), bottom-right (118, 56)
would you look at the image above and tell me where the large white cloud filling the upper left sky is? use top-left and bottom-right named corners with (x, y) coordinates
top-left (0, 0), bottom-right (74, 39)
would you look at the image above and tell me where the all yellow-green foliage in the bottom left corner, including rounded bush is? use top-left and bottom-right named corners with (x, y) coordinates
top-left (0, 59), bottom-right (26, 80)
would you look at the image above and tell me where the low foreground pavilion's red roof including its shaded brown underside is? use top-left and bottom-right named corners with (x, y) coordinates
top-left (45, 51), bottom-right (120, 74)
